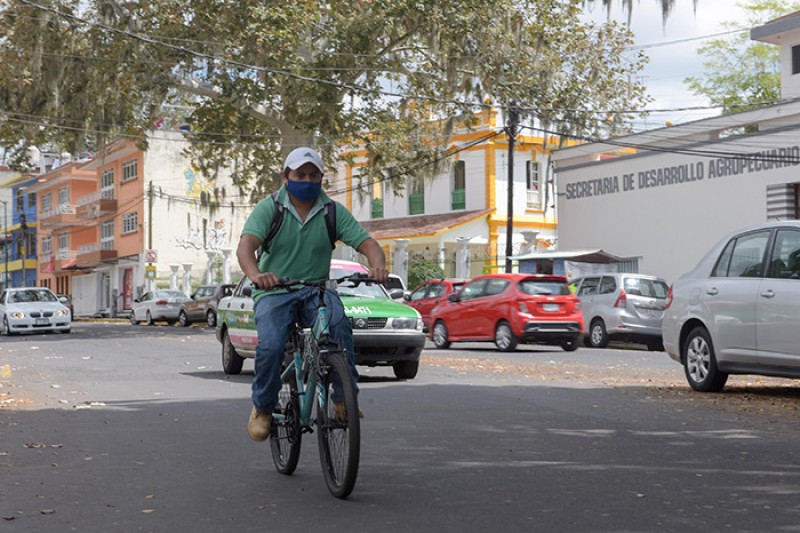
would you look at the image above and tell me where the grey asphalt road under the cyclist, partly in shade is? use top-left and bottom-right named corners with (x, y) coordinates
top-left (0, 323), bottom-right (800, 533)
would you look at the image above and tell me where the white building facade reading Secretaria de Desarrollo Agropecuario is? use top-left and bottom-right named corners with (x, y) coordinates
top-left (552, 13), bottom-right (800, 282)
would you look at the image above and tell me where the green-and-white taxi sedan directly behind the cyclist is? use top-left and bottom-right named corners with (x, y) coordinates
top-left (216, 260), bottom-right (425, 379)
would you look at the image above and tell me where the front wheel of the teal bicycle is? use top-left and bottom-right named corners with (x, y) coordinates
top-left (317, 353), bottom-right (361, 498)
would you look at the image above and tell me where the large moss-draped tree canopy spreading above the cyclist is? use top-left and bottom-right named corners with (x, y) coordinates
top-left (0, 0), bottom-right (647, 198)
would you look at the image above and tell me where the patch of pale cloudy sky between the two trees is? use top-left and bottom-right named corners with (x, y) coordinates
top-left (586, 0), bottom-right (747, 130)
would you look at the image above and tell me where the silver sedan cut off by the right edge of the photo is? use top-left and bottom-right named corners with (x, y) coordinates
top-left (663, 221), bottom-right (800, 392)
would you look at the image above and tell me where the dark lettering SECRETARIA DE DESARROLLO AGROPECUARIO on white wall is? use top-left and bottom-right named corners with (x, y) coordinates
top-left (564, 145), bottom-right (800, 200)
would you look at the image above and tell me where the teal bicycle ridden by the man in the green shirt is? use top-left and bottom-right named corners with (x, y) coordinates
top-left (269, 274), bottom-right (377, 498)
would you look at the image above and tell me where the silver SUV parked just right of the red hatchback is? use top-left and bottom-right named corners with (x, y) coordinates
top-left (573, 272), bottom-right (669, 351)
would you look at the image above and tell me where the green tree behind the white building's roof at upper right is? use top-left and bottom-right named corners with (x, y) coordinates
top-left (684, 0), bottom-right (800, 113)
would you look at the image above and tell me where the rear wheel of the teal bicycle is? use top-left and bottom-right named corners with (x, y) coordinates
top-left (269, 374), bottom-right (303, 476)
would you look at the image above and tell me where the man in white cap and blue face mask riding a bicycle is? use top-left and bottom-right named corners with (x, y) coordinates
top-left (236, 147), bottom-right (388, 441)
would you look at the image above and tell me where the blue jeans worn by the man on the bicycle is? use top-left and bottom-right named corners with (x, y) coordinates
top-left (252, 287), bottom-right (358, 413)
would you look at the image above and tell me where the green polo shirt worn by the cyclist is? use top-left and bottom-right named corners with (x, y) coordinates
top-left (242, 186), bottom-right (369, 301)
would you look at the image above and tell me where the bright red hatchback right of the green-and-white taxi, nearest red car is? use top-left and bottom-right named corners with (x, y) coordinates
top-left (431, 273), bottom-right (583, 352)
